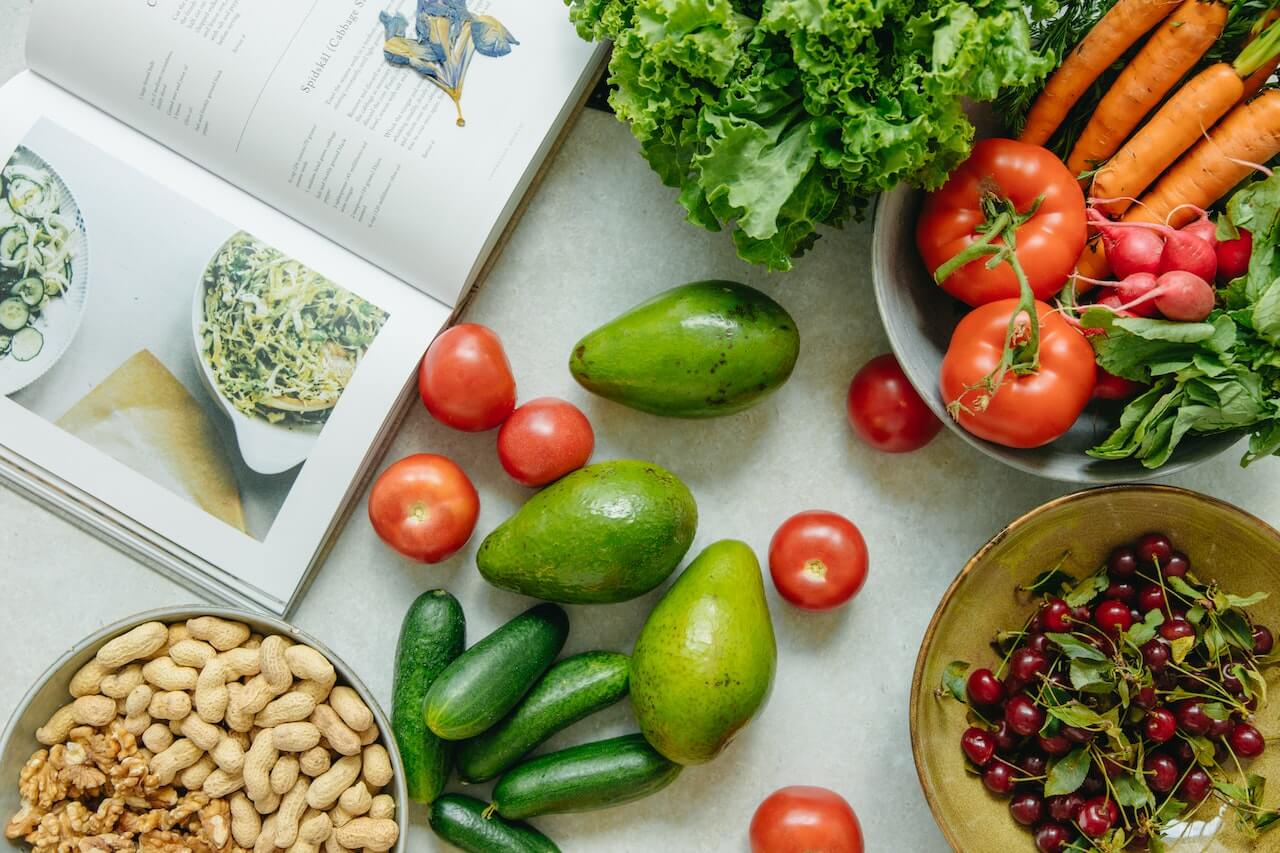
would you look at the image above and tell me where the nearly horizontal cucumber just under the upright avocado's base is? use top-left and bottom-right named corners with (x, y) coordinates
top-left (493, 734), bottom-right (682, 820)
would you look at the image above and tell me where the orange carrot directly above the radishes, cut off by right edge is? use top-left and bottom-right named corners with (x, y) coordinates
top-left (1124, 88), bottom-right (1280, 228)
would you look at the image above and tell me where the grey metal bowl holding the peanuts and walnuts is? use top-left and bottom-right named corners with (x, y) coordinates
top-left (0, 605), bottom-right (408, 853)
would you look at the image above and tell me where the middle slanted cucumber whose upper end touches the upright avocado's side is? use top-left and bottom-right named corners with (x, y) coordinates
top-left (457, 652), bottom-right (631, 783)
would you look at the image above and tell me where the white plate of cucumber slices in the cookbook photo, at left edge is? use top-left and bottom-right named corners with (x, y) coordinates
top-left (0, 145), bottom-right (88, 397)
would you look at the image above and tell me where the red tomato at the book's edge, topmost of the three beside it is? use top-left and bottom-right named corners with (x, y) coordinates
top-left (417, 323), bottom-right (516, 433)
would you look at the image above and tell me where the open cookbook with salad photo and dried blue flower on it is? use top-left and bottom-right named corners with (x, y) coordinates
top-left (0, 0), bottom-right (603, 613)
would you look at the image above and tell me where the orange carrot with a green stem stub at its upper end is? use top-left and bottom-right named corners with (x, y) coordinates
top-left (1092, 63), bottom-right (1244, 216)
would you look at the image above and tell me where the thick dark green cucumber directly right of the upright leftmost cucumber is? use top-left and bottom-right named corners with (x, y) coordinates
top-left (422, 596), bottom-right (568, 740)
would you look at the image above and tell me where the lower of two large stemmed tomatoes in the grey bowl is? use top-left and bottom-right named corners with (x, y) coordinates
top-left (941, 300), bottom-right (1097, 447)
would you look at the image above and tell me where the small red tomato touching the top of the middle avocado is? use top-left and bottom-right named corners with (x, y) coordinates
top-left (498, 397), bottom-right (595, 485)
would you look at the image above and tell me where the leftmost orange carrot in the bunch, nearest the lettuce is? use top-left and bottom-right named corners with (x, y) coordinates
top-left (1018, 0), bottom-right (1178, 145)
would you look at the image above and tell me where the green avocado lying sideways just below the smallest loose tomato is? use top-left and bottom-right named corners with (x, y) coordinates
top-left (476, 460), bottom-right (698, 605)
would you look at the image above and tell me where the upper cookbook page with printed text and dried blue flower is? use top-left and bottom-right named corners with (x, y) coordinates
top-left (27, 0), bottom-right (599, 305)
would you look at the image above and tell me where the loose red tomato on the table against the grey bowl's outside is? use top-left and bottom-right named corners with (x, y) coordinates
top-left (847, 352), bottom-right (942, 453)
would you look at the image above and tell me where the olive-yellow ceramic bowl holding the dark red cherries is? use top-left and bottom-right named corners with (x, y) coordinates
top-left (910, 485), bottom-right (1280, 853)
